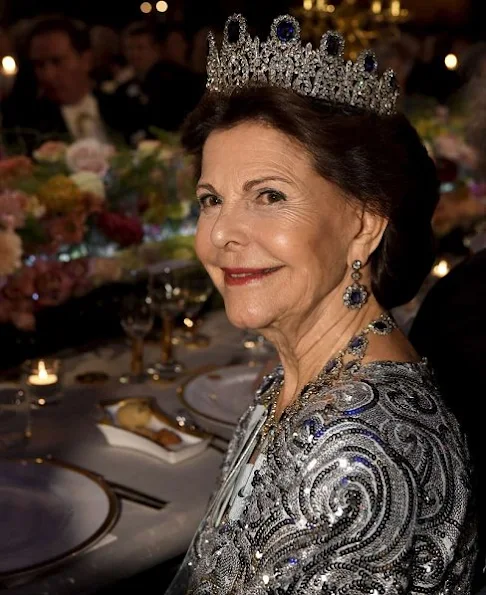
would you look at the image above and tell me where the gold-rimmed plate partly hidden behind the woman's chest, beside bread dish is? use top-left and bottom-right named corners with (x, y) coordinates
top-left (179, 364), bottom-right (262, 439)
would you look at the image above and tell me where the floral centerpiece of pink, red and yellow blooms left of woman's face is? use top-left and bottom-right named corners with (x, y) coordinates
top-left (0, 136), bottom-right (194, 330)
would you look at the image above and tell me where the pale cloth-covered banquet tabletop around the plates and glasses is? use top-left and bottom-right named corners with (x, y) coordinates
top-left (1, 311), bottom-right (249, 595)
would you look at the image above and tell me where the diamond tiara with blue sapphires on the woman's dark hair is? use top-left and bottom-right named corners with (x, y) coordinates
top-left (206, 14), bottom-right (399, 116)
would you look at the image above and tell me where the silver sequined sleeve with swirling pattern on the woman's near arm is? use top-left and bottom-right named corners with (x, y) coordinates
top-left (241, 383), bottom-right (468, 595)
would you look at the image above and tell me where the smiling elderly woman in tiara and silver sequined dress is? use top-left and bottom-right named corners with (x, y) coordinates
top-left (165, 15), bottom-right (475, 595)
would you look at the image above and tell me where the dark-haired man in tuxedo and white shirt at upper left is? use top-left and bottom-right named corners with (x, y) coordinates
top-left (2, 17), bottom-right (137, 152)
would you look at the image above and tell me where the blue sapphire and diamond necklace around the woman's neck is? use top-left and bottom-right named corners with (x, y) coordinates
top-left (260, 313), bottom-right (397, 444)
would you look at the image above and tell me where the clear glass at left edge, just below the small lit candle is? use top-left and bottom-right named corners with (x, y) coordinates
top-left (0, 383), bottom-right (32, 453)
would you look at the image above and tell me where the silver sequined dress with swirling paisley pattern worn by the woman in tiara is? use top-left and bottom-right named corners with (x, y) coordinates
top-left (169, 362), bottom-right (475, 595)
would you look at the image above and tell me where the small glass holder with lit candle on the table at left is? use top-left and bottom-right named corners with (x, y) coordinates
top-left (24, 358), bottom-right (63, 407)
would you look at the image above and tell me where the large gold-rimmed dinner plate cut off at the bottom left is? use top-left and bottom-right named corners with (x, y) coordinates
top-left (0, 459), bottom-right (119, 582)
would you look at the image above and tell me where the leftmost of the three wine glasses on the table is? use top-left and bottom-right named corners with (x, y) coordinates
top-left (119, 294), bottom-right (154, 384)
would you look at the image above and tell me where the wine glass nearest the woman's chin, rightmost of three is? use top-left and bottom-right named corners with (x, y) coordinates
top-left (182, 267), bottom-right (214, 349)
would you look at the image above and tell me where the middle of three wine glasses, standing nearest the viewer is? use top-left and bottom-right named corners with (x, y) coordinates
top-left (147, 267), bottom-right (185, 380)
